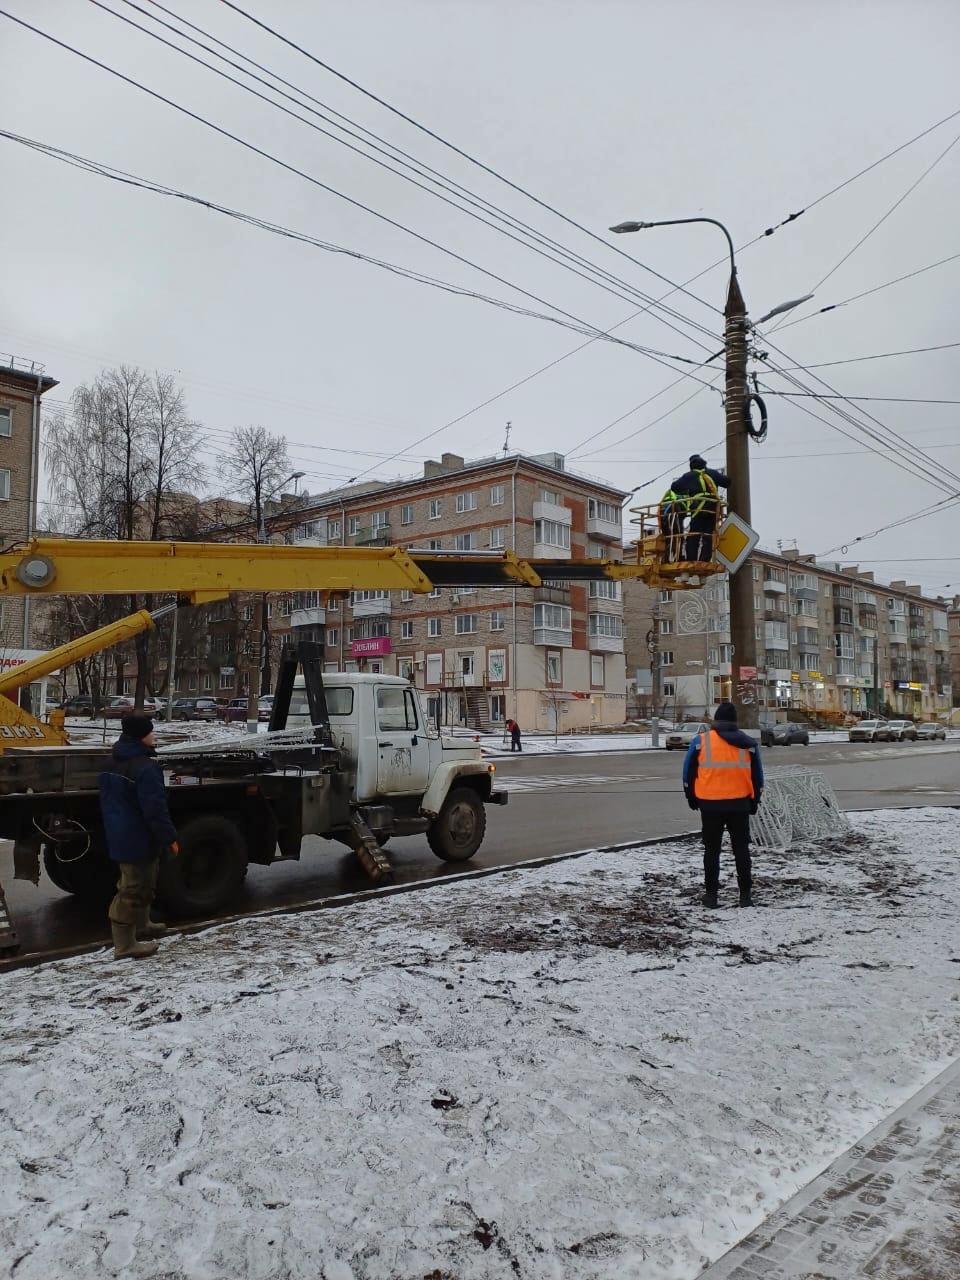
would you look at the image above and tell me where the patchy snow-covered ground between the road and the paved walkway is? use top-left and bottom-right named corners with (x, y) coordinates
top-left (0, 809), bottom-right (960, 1280)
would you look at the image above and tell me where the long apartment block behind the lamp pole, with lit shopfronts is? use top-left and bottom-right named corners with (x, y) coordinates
top-left (625, 552), bottom-right (960, 719)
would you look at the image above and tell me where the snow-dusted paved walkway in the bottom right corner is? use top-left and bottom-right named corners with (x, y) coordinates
top-left (701, 1060), bottom-right (960, 1280)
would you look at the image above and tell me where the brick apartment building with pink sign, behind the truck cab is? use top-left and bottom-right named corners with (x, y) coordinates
top-left (273, 453), bottom-right (626, 730)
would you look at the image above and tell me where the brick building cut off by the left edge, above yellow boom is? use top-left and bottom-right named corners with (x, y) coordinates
top-left (0, 356), bottom-right (56, 652)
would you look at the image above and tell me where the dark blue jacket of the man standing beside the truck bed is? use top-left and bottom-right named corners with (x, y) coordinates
top-left (99, 733), bottom-right (177, 863)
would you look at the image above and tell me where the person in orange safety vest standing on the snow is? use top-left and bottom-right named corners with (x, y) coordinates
top-left (684, 703), bottom-right (763, 908)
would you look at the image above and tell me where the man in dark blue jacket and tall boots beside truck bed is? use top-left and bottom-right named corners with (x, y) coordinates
top-left (99, 714), bottom-right (180, 960)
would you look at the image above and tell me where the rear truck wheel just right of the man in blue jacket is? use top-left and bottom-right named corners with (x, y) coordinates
top-left (157, 814), bottom-right (247, 916)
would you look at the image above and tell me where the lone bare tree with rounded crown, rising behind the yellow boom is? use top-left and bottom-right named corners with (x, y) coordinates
top-left (220, 426), bottom-right (291, 701)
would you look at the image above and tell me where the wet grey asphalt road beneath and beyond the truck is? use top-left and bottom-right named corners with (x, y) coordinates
top-left (0, 741), bottom-right (960, 951)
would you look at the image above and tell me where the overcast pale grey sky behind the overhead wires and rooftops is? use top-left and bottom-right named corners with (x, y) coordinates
top-left (0, 0), bottom-right (960, 591)
